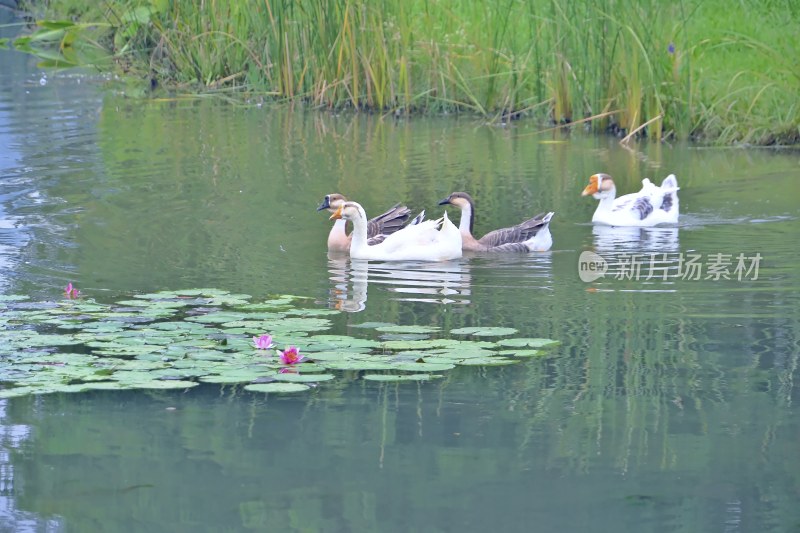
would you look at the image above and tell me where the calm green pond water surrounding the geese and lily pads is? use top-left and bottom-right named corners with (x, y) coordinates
top-left (0, 12), bottom-right (800, 532)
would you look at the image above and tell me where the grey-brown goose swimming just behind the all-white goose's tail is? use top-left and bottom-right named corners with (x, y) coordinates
top-left (439, 192), bottom-right (554, 252)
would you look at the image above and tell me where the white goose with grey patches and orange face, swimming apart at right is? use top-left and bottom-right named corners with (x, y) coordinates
top-left (581, 174), bottom-right (680, 226)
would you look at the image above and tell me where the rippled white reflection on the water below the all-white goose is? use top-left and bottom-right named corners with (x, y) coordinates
top-left (328, 254), bottom-right (471, 313)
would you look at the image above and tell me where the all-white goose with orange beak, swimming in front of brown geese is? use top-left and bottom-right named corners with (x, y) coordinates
top-left (331, 202), bottom-right (461, 261)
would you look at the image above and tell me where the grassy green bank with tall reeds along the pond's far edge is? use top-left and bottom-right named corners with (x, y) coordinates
top-left (12, 0), bottom-right (800, 144)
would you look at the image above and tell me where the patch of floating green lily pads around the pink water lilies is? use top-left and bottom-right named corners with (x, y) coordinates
top-left (0, 289), bottom-right (557, 398)
